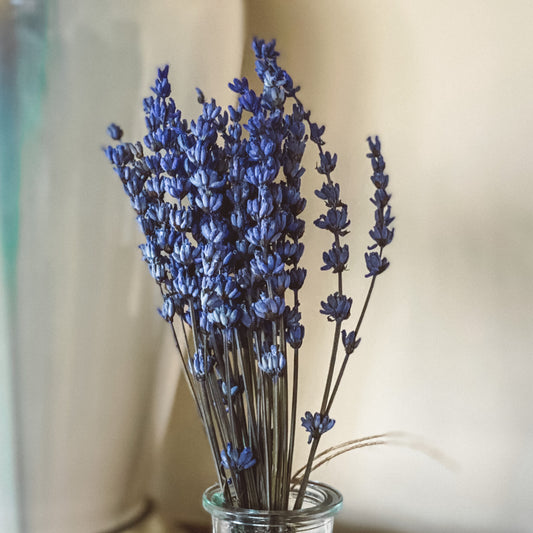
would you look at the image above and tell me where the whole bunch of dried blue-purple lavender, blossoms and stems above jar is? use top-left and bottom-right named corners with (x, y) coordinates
top-left (105, 39), bottom-right (394, 510)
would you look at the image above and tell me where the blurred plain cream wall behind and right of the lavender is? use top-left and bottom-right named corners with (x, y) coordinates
top-left (154, 0), bottom-right (533, 533)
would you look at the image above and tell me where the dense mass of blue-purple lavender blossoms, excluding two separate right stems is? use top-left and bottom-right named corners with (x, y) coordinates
top-left (106, 44), bottom-right (305, 350)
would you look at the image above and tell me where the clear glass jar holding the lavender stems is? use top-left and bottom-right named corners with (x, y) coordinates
top-left (203, 482), bottom-right (342, 533)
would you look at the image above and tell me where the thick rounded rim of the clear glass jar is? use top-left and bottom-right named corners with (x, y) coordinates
top-left (202, 481), bottom-right (342, 525)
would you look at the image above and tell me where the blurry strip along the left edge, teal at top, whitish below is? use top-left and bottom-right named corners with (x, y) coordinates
top-left (0, 2), bottom-right (47, 533)
